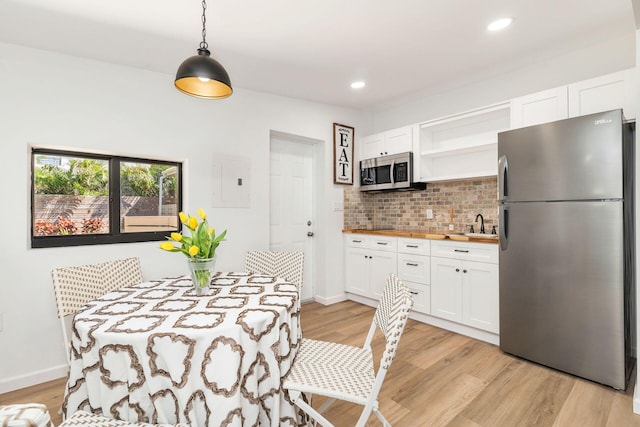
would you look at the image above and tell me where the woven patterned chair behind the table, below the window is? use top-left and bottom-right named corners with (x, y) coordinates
top-left (51, 257), bottom-right (142, 363)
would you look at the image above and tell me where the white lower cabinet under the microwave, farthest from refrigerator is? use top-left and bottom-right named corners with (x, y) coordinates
top-left (345, 235), bottom-right (398, 299)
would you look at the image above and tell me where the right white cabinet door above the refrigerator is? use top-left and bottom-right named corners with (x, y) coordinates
top-left (569, 69), bottom-right (636, 119)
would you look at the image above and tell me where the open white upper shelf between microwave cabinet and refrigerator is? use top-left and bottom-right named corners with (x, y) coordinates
top-left (414, 103), bottom-right (510, 182)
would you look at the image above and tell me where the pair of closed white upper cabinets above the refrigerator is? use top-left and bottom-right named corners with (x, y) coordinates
top-left (511, 69), bottom-right (636, 129)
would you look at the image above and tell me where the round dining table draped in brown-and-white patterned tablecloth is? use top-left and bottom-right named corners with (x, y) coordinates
top-left (63, 272), bottom-right (302, 427)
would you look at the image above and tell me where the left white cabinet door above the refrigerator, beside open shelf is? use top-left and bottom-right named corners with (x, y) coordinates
top-left (511, 86), bottom-right (569, 129)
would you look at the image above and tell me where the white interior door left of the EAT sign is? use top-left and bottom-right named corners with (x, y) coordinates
top-left (269, 136), bottom-right (315, 301)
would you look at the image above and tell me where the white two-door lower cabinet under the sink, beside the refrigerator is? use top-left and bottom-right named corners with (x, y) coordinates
top-left (431, 242), bottom-right (499, 334)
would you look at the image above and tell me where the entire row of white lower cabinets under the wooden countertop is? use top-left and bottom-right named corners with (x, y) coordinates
top-left (345, 234), bottom-right (499, 343)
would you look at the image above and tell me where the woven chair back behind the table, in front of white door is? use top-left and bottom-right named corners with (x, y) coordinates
top-left (245, 251), bottom-right (304, 290)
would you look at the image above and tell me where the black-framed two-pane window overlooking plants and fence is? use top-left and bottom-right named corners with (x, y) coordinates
top-left (31, 148), bottom-right (182, 248)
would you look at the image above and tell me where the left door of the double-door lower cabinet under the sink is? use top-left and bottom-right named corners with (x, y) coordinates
top-left (431, 257), bottom-right (462, 322)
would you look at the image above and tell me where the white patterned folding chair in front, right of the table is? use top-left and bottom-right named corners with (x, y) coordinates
top-left (283, 275), bottom-right (413, 427)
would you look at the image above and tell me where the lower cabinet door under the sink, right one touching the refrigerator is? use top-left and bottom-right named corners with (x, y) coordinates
top-left (462, 261), bottom-right (500, 334)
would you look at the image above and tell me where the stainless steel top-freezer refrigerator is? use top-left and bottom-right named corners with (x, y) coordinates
top-left (498, 110), bottom-right (635, 389)
